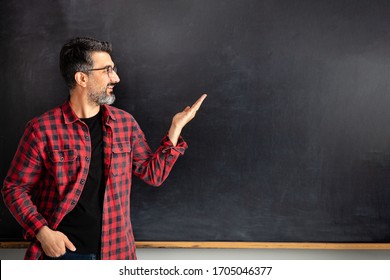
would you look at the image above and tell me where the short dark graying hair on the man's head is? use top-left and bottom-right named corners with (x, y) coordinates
top-left (60, 37), bottom-right (112, 89)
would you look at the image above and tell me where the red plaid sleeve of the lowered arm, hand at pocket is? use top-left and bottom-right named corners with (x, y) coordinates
top-left (2, 122), bottom-right (47, 239)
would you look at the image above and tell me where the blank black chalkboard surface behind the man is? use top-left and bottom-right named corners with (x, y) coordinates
top-left (0, 0), bottom-right (390, 243)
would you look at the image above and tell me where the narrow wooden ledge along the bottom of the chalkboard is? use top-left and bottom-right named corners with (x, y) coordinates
top-left (0, 241), bottom-right (390, 250)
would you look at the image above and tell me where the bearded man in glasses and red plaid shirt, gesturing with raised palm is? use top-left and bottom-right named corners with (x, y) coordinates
top-left (2, 38), bottom-right (206, 259)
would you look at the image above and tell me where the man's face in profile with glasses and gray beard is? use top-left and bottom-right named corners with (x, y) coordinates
top-left (88, 52), bottom-right (120, 105)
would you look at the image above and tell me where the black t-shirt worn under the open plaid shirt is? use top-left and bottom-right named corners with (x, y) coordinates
top-left (57, 111), bottom-right (105, 255)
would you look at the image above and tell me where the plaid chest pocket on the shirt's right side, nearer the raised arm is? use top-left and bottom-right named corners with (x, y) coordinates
top-left (111, 142), bottom-right (131, 176)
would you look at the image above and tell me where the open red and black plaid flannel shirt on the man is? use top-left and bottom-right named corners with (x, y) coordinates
top-left (2, 99), bottom-right (187, 259)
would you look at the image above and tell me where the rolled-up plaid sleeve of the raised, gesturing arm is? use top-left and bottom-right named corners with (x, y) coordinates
top-left (133, 121), bottom-right (188, 186)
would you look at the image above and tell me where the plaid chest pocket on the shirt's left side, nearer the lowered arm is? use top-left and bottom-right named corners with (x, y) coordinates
top-left (49, 150), bottom-right (80, 187)
